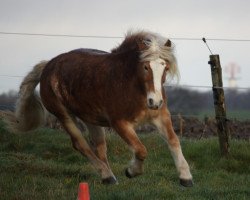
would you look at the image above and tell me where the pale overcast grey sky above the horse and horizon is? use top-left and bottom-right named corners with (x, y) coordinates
top-left (0, 0), bottom-right (250, 93)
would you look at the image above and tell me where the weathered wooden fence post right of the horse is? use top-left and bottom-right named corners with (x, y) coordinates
top-left (208, 55), bottom-right (229, 157)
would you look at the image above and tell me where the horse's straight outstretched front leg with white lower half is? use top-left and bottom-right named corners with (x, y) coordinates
top-left (153, 107), bottom-right (193, 187)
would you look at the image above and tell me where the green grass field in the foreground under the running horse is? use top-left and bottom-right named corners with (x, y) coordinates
top-left (0, 121), bottom-right (250, 200)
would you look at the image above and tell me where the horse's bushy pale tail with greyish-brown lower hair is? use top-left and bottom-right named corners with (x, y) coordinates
top-left (8, 61), bottom-right (48, 132)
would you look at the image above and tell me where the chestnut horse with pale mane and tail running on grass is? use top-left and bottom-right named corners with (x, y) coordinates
top-left (9, 31), bottom-right (193, 187)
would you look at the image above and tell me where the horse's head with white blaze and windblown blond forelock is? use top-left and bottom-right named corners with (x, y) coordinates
top-left (137, 38), bottom-right (177, 110)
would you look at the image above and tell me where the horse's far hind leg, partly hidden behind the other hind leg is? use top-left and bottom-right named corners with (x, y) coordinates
top-left (85, 123), bottom-right (110, 174)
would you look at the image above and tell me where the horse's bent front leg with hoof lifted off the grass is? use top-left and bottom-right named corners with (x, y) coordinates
top-left (113, 120), bottom-right (147, 178)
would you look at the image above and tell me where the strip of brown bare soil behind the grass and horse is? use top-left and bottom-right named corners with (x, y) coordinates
top-left (0, 111), bottom-right (250, 141)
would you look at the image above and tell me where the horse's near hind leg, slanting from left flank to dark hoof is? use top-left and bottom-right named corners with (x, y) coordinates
top-left (59, 114), bottom-right (116, 184)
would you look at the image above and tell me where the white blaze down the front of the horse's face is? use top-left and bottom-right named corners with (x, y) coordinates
top-left (147, 58), bottom-right (166, 105)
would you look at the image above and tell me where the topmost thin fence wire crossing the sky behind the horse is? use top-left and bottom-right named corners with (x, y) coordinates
top-left (0, 31), bottom-right (250, 42)
